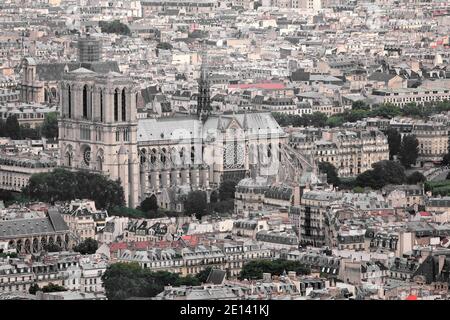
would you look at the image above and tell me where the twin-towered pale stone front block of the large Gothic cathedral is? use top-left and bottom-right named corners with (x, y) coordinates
top-left (59, 68), bottom-right (139, 207)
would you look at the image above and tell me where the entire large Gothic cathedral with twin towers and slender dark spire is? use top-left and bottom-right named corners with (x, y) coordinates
top-left (59, 53), bottom-right (286, 207)
